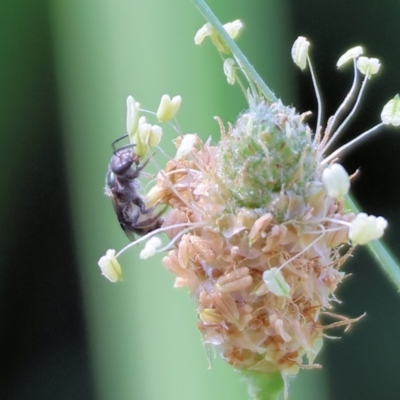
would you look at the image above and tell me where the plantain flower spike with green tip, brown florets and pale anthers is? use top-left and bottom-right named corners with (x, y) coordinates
top-left (100, 30), bottom-right (399, 390)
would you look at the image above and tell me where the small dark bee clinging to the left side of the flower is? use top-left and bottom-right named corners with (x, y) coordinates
top-left (105, 135), bottom-right (165, 241)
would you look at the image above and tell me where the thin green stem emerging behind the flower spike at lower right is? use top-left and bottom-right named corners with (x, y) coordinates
top-left (346, 196), bottom-right (400, 291)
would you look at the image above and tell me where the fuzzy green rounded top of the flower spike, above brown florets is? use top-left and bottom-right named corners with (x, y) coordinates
top-left (217, 102), bottom-right (318, 209)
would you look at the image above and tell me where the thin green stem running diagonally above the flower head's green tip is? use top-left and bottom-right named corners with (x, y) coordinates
top-left (193, 0), bottom-right (278, 102)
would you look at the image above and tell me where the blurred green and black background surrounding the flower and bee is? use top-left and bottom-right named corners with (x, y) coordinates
top-left (0, 0), bottom-right (400, 400)
